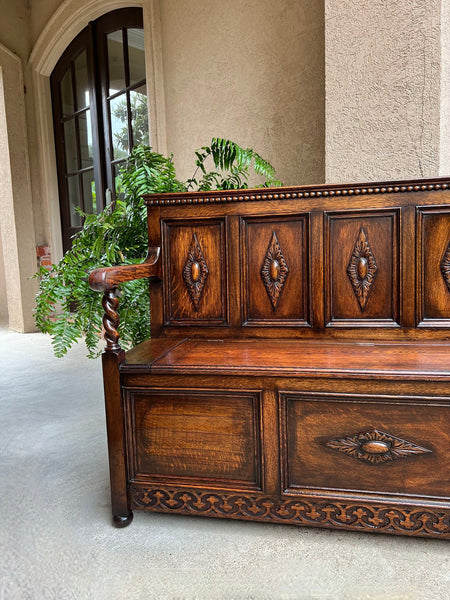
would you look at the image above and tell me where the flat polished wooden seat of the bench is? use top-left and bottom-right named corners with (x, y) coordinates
top-left (124, 338), bottom-right (450, 381)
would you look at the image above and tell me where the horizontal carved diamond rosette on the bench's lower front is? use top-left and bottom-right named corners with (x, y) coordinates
top-left (325, 429), bottom-right (431, 465)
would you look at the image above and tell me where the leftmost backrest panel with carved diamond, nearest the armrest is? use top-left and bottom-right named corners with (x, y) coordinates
top-left (163, 219), bottom-right (227, 325)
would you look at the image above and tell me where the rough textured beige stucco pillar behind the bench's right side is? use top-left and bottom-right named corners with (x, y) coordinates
top-left (325, 0), bottom-right (442, 181)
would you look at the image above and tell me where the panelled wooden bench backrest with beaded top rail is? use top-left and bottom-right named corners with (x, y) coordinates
top-left (146, 179), bottom-right (450, 340)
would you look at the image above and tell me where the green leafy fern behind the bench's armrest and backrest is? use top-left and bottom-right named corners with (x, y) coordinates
top-left (35, 138), bottom-right (281, 358)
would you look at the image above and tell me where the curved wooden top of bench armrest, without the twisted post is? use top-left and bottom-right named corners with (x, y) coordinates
top-left (89, 246), bottom-right (161, 292)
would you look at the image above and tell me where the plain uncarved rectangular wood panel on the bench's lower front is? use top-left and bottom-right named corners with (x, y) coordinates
top-left (126, 390), bottom-right (261, 489)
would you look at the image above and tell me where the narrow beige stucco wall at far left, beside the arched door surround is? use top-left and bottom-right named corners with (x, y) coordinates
top-left (0, 0), bottom-right (36, 331)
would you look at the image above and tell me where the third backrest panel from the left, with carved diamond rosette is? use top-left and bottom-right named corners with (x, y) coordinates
top-left (325, 211), bottom-right (400, 327)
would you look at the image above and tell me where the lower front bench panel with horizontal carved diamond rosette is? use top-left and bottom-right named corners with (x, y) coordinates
top-left (282, 393), bottom-right (450, 497)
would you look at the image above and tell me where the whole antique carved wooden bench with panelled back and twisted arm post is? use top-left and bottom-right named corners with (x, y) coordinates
top-left (90, 179), bottom-right (450, 539)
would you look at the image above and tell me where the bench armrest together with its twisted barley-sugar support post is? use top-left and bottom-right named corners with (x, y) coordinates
top-left (89, 246), bottom-right (161, 355)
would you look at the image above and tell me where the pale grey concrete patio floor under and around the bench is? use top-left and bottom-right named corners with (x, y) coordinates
top-left (0, 331), bottom-right (450, 600)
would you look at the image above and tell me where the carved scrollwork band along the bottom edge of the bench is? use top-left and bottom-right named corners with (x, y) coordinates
top-left (131, 487), bottom-right (450, 539)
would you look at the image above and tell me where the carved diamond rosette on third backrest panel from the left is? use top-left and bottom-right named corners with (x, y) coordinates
top-left (347, 227), bottom-right (378, 310)
